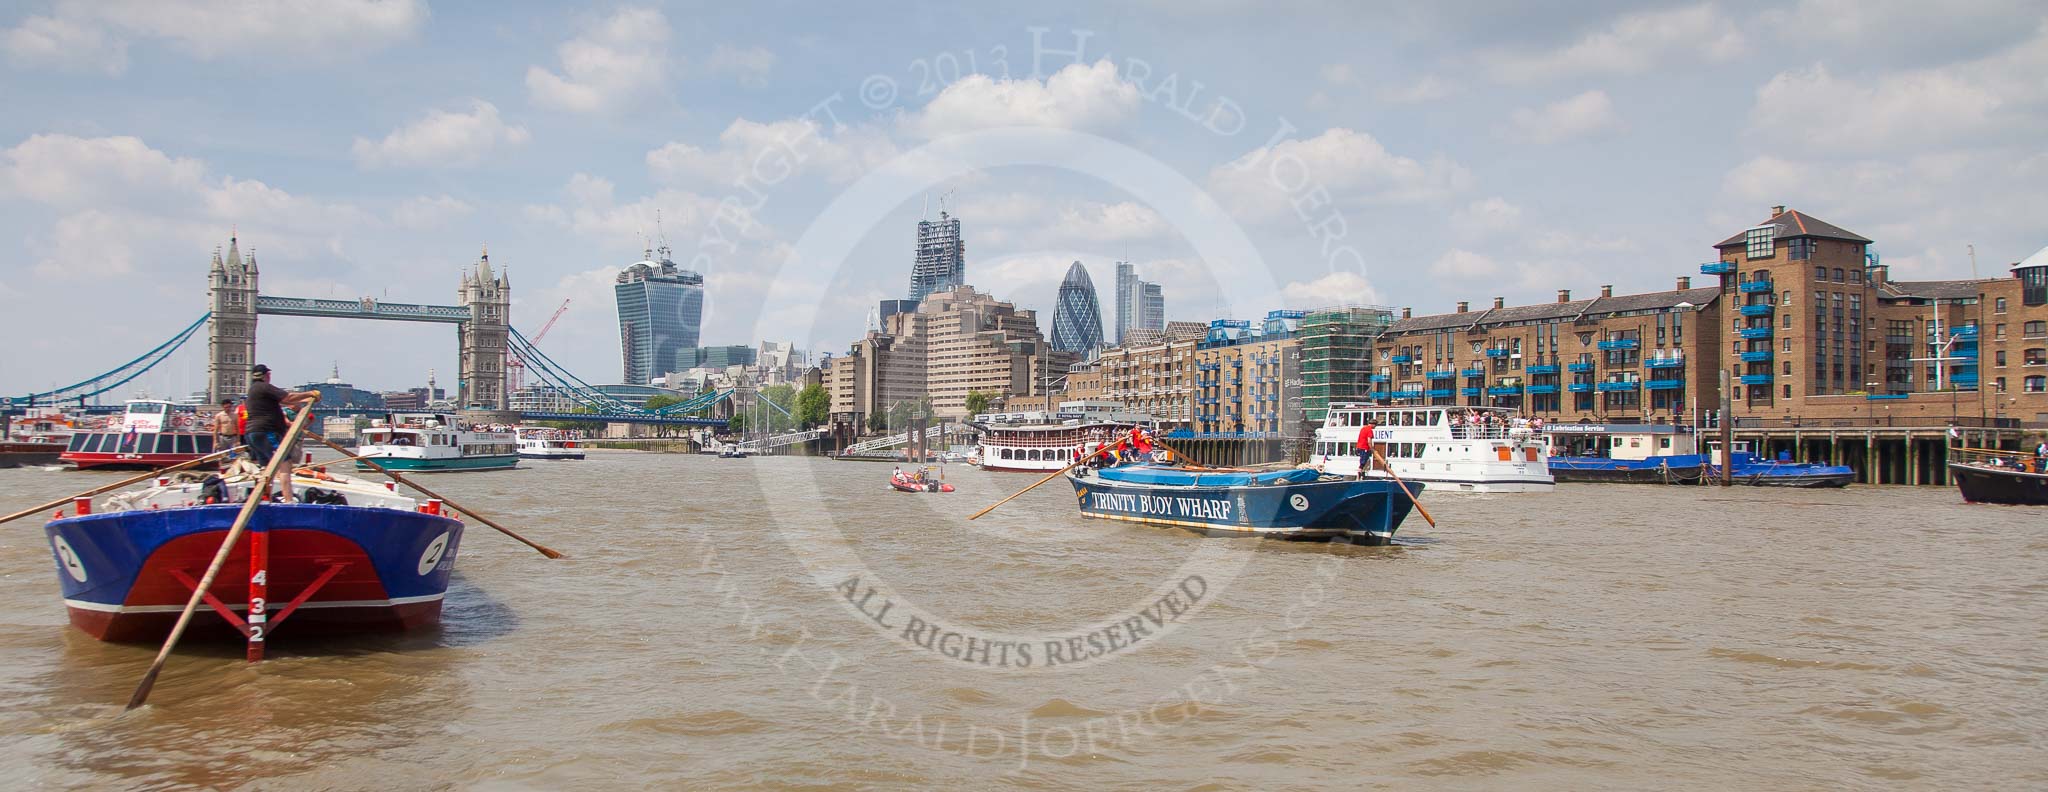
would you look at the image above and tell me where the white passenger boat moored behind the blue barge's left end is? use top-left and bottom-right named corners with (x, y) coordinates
top-left (971, 399), bottom-right (1159, 473)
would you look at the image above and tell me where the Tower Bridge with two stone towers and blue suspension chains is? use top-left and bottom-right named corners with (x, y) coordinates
top-left (0, 237), bottom-right (731, 428)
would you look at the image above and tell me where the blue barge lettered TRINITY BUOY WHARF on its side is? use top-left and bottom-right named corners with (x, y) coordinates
top-left (1067, 465), bottom-right (1421, 544)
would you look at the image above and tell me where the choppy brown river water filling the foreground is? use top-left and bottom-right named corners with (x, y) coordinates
top-left (0, 452), bottom-right (2048, 790)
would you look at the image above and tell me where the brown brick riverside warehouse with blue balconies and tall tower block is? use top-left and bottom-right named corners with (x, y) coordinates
top-left (1359, 207), bottom-right (2048, 483)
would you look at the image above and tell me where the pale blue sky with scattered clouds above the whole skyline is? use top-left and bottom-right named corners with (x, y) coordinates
top-left (0, 0), bottom-right (2048, 395)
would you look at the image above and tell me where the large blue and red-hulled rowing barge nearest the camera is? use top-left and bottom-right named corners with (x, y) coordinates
top-left (43, 473), bottom-right (463, 642)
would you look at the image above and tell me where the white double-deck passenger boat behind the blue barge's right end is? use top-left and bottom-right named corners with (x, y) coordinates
top-left (1309, 403), bottom-right (1556, 493)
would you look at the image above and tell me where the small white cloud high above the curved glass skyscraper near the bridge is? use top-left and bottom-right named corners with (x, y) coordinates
top-left (526, 6), bottom-right (670, 113)
